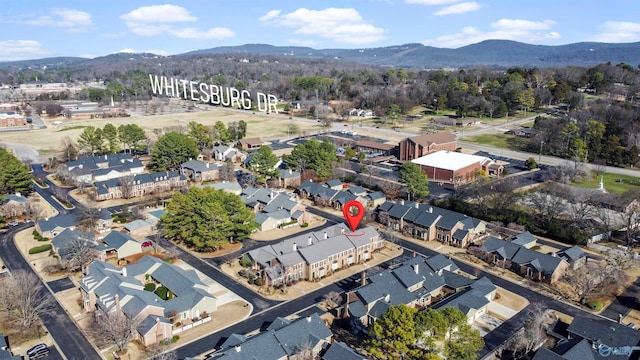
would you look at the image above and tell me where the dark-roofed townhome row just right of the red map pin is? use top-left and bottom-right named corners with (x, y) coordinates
top-left (376, 200), bottom-right (487, 247)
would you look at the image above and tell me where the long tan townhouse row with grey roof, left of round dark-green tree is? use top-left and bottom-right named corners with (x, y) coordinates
top-left (94, 171), bottom-right (187, 201)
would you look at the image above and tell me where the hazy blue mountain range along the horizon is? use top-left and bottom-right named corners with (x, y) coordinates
top-left (0, 40), bottom-right (640, 69)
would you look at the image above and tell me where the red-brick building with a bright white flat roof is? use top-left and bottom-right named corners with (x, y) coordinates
top-left (411, 150), bottom-right (504, 185)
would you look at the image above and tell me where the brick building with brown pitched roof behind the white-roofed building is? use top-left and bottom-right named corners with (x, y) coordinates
top-left (398, 132), bottom-right (458, 161)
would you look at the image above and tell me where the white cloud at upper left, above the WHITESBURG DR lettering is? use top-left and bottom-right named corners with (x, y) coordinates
top-left (120, 4), bottom-right (235, 39)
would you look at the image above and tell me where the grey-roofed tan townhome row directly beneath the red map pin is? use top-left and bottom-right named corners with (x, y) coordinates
top-left (243, 224), bottom-right (384, 285)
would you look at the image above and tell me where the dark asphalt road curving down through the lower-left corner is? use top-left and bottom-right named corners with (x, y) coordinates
top-left (0, 224), bottom-right (100, 359)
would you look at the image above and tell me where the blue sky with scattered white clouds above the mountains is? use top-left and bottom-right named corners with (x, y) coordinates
top-left (0, 0), bottom-right (640, 61)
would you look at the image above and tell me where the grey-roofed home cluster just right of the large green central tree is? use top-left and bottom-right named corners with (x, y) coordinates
top-left (240, 187), bottom-right (306, 231)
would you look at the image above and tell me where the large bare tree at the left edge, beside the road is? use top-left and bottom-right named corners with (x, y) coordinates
top-left (0, 270), bottom-right (52, 329)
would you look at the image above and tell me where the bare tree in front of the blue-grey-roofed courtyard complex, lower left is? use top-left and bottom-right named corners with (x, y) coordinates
top-left (90, 309), bottom-right (139, 353)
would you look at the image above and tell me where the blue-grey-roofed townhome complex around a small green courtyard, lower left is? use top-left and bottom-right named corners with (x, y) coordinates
top-left (80, 256), bottom-right (217, 346)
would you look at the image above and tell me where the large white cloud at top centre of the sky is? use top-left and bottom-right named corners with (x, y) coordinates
top-left (259, 8), bottom-right (385, 45)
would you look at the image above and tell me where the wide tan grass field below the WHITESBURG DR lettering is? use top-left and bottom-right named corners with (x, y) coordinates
top-left (2, 107), bottom-right (321, 158)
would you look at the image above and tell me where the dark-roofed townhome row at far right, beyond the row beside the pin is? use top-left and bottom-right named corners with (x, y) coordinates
top-left (473, 236), bottom-right (569, 284)
